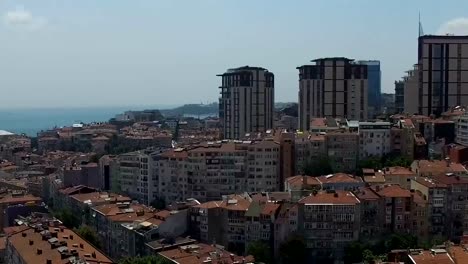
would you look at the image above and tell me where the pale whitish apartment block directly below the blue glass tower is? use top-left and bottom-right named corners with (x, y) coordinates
top-left (359, 122), bottom-right (391, 159)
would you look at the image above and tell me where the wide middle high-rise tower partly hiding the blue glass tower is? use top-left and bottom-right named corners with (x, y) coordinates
top-left (297, 57), bottom-right (368, 131)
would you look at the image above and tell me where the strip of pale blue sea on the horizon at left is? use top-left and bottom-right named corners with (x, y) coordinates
top-left (0, 105), bottom-right (176, 137)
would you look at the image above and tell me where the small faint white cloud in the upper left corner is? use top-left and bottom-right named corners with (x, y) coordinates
top-left (3, 8), bottom-right (47, 30)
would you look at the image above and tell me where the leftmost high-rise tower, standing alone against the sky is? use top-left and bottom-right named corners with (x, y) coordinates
top-left (218, 66), bottom-right (275, 139)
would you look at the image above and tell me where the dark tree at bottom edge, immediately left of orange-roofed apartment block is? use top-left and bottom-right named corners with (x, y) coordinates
top-left (279, 235), bottom-right (306, 264)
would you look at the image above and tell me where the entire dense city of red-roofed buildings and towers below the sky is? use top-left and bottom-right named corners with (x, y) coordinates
top-left (4, 31), bottom-right (468, 264)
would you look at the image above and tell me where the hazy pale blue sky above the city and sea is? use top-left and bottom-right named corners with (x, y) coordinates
top-left (0, 0), bottom-right (468, 108)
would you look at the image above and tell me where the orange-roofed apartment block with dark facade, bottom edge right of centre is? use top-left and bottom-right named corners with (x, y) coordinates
top-left (299, 191), bottom-right (361, 263)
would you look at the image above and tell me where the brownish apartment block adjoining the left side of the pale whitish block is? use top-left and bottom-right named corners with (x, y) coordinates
top-left (325, 131), bottom-right (360, 172)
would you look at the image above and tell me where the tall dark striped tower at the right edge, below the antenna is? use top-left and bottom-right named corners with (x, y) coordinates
top-left (418, 35), bottom-right (468, 115)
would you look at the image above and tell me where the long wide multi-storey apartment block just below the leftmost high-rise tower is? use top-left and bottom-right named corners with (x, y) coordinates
top-left (187, 140), bottom-right (281, 201)
